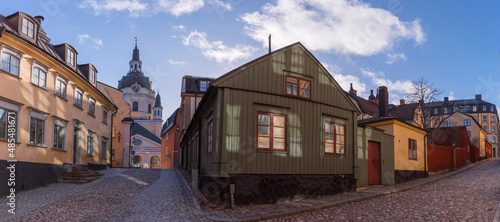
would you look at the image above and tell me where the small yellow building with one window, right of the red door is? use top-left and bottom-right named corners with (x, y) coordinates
top-left (358, 117), bottom-right (427, 183)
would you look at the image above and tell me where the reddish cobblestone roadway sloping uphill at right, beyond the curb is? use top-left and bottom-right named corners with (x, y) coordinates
top-left (272, 160), bottom-right (500, 221)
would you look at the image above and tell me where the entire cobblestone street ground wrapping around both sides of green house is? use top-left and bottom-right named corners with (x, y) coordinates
top-left (0, 159), bottom-right (500, 221)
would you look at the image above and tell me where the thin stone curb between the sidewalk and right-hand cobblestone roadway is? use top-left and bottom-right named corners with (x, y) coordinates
top-left (212, 159), bottom-right (492, 222)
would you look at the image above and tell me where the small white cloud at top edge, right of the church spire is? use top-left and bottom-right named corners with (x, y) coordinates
top-left (155, 0), bottom-right (205, 17)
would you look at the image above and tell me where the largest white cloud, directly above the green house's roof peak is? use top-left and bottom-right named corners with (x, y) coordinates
top-left (240, 0), bottom-right (425, 56)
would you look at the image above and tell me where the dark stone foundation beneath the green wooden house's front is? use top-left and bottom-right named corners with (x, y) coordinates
top-left (200, 174), bottom-right (356, 206)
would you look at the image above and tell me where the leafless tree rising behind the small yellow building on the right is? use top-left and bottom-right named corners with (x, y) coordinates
top-left (406, 77), bottom-right (443, 130)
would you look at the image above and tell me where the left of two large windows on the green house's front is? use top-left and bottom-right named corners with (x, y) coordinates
top-left (257, 113), bottom-right (286, 150)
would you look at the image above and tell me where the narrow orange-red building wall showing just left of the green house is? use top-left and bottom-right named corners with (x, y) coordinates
top-left (161, 109), bottom-right (180, 169)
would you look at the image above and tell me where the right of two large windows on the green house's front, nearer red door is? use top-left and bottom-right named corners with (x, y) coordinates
top-left (325, 122), bottom-right (345, 155)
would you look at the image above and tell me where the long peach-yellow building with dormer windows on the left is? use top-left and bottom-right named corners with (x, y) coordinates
top-left (0, 12), bottom-right (117, 191)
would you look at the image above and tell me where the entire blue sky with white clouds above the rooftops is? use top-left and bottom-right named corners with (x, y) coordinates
top-left (0, 0), bottom-right (500, 120)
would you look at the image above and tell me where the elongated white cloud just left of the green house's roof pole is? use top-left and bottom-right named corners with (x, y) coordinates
top-left (182, 30), bottom-right (257, 63)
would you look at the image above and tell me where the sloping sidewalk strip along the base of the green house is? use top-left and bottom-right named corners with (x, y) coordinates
top-left (182, 159), bottom-right (491, 221)
